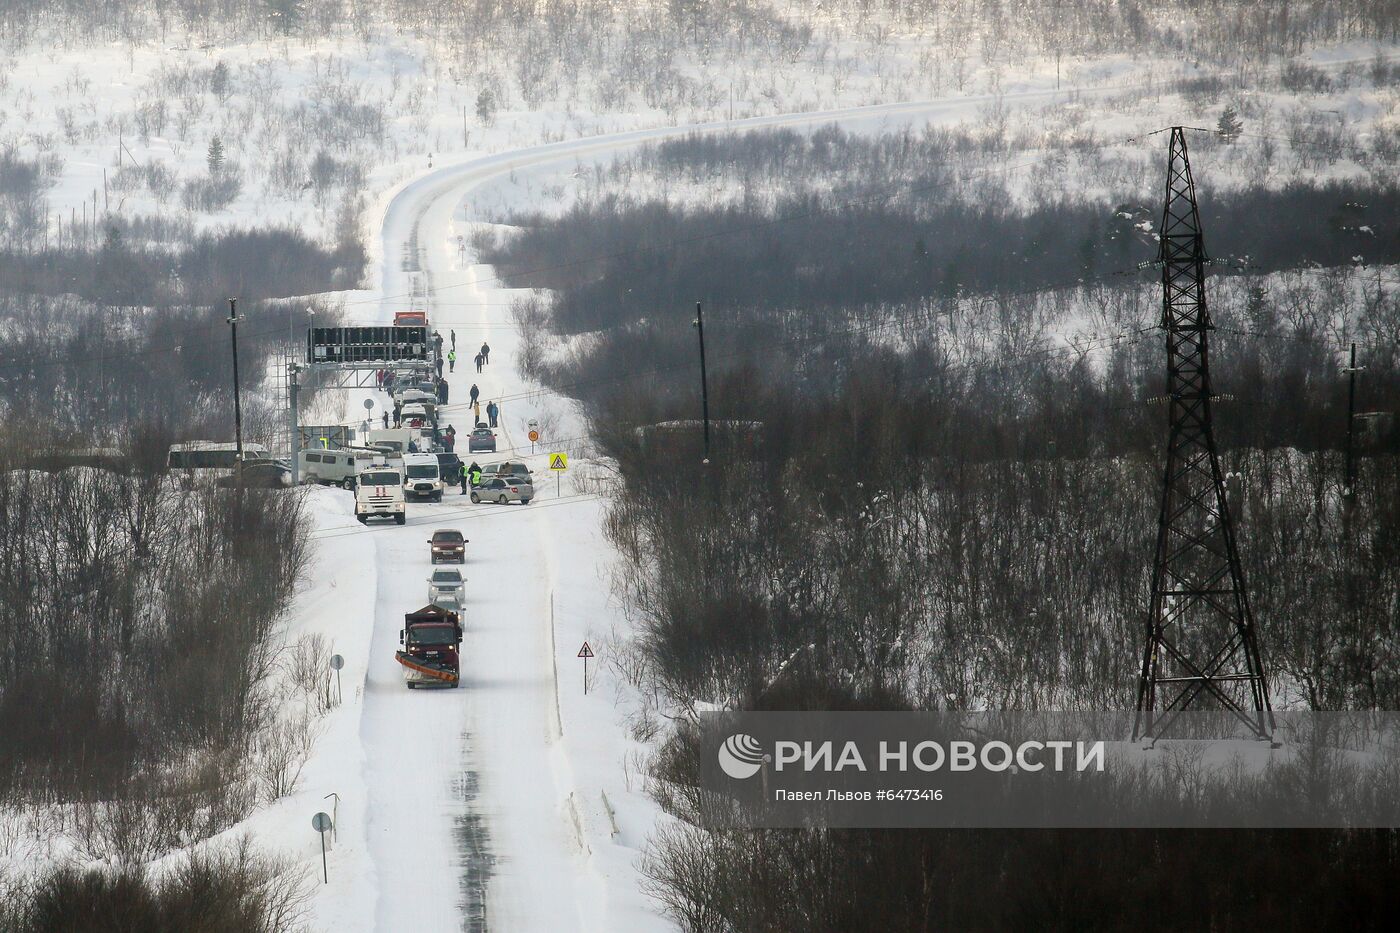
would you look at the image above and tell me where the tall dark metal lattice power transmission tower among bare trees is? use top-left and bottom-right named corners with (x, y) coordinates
top-left (1133, 126), bottom-right (1274, 738)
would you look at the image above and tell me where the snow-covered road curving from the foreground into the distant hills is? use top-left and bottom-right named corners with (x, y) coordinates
top-left (344, 92), bottom-right (1086, 933)
